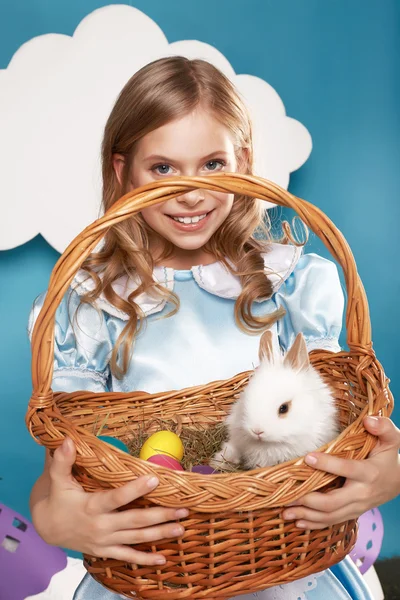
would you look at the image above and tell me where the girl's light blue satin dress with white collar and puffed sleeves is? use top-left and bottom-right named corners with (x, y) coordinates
top-left (29, 244), bottom-right (372, 600)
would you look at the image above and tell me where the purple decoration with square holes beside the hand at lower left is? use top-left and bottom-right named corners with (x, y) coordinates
top-left (0, 504), bottom-right (67, 600)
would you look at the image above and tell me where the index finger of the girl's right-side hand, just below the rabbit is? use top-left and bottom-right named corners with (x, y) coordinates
top-left (305, 452), bottom-right (377, 483)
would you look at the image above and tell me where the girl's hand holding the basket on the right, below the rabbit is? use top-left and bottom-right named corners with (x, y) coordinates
top-left (283, 417), bottom-right (400, 529)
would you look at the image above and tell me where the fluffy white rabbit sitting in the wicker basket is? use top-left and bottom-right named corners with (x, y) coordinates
top-left (210, 331), bottom-right (339, 469)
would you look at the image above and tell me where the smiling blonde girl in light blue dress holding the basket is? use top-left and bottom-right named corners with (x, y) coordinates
top-left (30, 57), bottom-right (400, 600)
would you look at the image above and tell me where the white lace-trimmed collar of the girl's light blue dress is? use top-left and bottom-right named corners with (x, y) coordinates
top-left (71, 243), bottom-right (302, 321)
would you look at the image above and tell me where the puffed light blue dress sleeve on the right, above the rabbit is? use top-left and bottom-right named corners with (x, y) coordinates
top-left (275, 254), bottom-right (344, 352)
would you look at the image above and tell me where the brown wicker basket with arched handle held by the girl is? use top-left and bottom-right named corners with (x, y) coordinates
top-left (26, 174), bottom-right (393, 600)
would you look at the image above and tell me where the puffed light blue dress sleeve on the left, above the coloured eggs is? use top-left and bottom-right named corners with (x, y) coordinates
top-left (28, 289), bottom-right (112, 392)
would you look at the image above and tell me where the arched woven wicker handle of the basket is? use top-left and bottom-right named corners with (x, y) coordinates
top-left (30, 173), bottom-right (371, 410)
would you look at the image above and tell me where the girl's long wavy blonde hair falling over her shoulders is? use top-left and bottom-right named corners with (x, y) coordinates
top-left (81, 56), bottom-right (290, 377)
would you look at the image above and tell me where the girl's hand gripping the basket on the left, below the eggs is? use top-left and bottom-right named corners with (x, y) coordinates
top-left (32, 438), bottom-right (188, 565)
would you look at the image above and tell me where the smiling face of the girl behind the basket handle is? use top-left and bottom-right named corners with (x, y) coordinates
top-left (114, 108), bottom-right (237, 269)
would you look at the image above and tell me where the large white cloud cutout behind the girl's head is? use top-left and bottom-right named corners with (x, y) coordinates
top-left (0, 5), bottom-right (312, 252)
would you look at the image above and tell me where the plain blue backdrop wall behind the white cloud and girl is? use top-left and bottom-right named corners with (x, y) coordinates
top-left (0, 0), bottom-right (400, 556)
